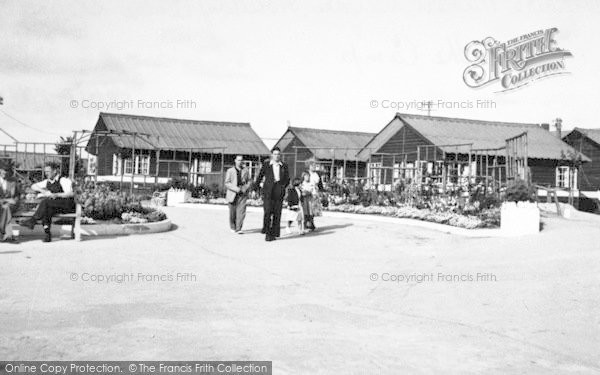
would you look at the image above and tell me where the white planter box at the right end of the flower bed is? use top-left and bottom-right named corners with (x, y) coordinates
top-left (500, 202), bottom-right (540, 235)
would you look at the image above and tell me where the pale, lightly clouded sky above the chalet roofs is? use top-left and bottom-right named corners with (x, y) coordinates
top-left (0, 0), bottom-right (600, 146)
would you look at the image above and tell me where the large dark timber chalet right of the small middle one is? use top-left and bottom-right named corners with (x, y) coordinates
top-left (358, 113), bottom-right (590, 188)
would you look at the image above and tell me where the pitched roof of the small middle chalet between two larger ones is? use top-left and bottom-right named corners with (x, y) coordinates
top-left (276, 126), bottom-right (375, 160)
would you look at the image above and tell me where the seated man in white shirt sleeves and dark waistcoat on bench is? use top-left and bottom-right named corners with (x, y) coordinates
top-left (21, 162), bottom-right (75, 242)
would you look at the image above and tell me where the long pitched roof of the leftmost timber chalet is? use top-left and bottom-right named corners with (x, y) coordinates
top-left (87, 112), bottom-right (269, 155)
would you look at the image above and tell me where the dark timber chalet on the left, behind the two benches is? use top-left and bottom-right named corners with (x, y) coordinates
top-left (86, 113), bottom-right (269, 186)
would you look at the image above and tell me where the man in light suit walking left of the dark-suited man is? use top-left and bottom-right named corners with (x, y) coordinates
top-left (225, 155), bottom-right (252, 234)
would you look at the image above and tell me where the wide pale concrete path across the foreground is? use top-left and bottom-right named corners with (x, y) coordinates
top-left (0, 208), bottom-right (600, 374)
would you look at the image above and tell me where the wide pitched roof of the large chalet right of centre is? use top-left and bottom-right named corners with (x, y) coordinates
top-left (359, 113), bottom-right (589, 161)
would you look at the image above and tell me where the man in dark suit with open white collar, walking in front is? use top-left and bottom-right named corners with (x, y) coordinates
top-left (256, 147), bottom-right (290, 241)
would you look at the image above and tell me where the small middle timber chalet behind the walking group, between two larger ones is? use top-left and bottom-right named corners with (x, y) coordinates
top-left (275, 126), bottom-right (375, 181)
